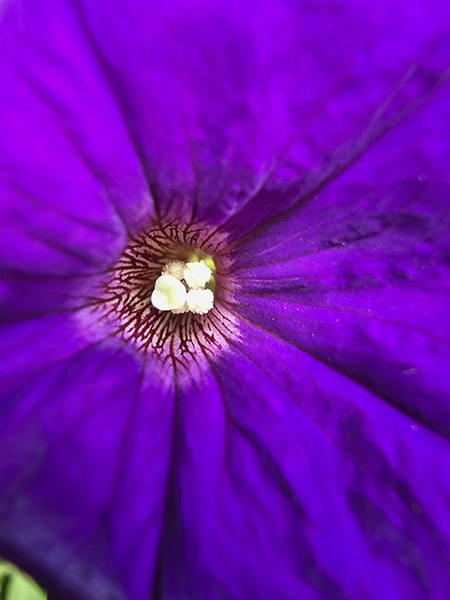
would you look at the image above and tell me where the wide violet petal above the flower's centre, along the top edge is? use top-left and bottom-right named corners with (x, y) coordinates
top-left (7, 0), bottom-right (448, 229)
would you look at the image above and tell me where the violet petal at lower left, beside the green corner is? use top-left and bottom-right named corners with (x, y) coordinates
top-left (0, 342), bottom-right (173, 599)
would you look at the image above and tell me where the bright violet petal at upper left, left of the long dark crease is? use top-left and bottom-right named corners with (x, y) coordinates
top-left (0, 2), bottom-right (153, 275)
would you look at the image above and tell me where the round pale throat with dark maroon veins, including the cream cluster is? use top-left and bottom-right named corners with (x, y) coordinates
top-left (91, 224), bottom-right (238, 380)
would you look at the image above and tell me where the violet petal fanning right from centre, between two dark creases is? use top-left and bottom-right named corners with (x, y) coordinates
top-left (235, 77), bottom-right (450, 437)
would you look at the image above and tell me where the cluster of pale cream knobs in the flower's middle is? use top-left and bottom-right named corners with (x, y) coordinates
top-left (151, 260), bottom-right (214, 315)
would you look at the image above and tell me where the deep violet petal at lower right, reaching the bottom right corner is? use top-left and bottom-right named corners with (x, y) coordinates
top-left (150, 325), bottom-right (450, 600)
